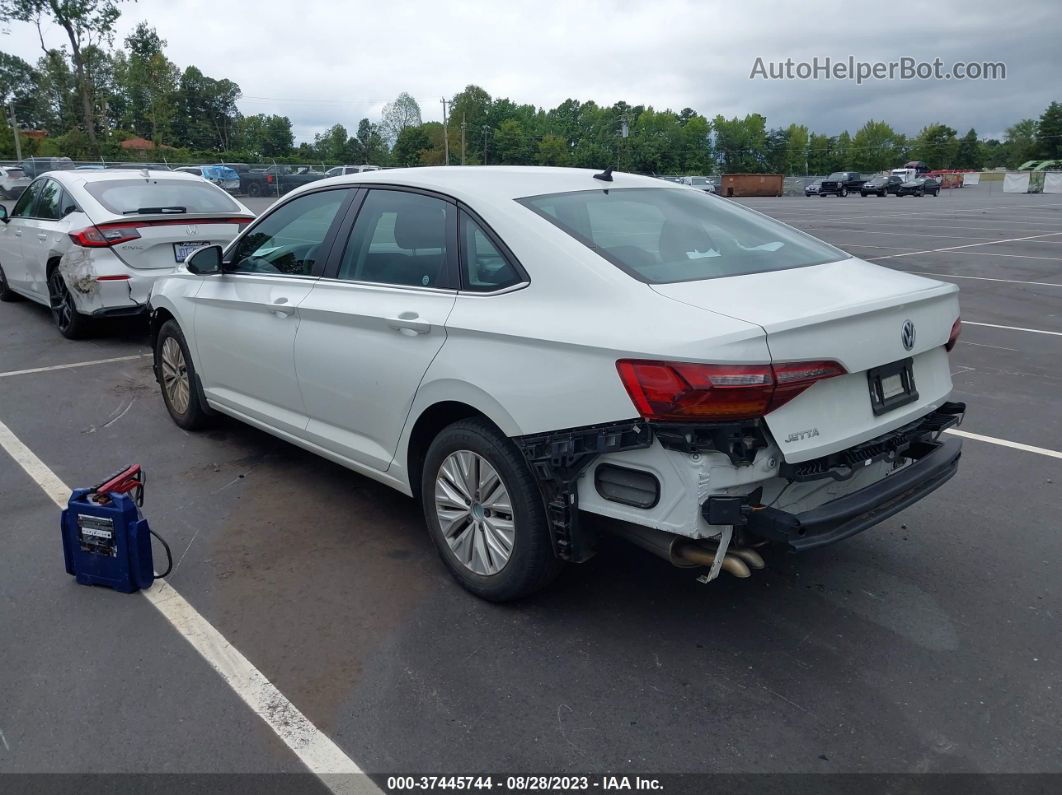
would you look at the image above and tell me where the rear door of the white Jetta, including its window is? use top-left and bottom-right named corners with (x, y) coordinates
top-left (295, 189), bottom-right (458, 471)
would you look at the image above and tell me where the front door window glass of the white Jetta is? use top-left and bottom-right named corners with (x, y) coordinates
top-left (225, 190), bottom-right (349, 276)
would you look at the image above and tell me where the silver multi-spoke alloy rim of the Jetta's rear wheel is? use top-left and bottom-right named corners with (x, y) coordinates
top-left (435, 450), bottom-right (516, 576)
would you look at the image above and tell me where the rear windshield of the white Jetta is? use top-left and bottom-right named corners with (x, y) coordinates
top-left (516, 188), bottom-right (850, 284)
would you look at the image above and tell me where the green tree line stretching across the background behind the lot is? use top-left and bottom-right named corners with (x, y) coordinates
top-left (0, 0), bottom-right (1062, 174)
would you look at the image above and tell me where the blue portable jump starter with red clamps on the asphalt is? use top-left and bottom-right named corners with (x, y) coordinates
top-left (59, 464), bottom-right (173, 593)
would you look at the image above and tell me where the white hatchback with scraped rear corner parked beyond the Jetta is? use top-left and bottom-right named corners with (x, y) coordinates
top-left (0, 170), bottom-right (254, 339)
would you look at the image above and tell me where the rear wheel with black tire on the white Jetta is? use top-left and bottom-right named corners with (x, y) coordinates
top-left (421, 418), bottom-right (563, 602)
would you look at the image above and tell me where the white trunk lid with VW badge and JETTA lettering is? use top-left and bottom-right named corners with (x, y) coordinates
top-left (652, 259), bottom-right (959, 463)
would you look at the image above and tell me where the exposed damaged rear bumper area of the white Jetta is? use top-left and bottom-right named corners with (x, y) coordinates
top-left (514, 402), bottom-right (965, 580)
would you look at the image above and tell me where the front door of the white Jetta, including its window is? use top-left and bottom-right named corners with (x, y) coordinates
top-left (192, 189), bottom-right (355, 435)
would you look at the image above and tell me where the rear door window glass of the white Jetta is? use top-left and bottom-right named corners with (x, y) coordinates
top-left (337, 190), bottom-right (456, 287)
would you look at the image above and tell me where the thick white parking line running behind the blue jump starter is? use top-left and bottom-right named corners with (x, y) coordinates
top-left (0, 421), bottom-right (380, 795)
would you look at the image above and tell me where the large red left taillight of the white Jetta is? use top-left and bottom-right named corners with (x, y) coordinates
top-left (616, 359), bottom-right (847, 422)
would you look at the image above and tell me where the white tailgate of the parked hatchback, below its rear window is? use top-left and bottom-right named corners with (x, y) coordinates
top-left (104, 214), bottom-right (252, 270)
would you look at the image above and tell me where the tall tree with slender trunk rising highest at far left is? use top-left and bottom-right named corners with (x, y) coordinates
top-left (0, 0), bottom-right (120, 150)
